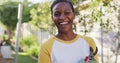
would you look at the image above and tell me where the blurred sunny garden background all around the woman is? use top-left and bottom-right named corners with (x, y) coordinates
top-left (0, 0), bottom-right (120, 63)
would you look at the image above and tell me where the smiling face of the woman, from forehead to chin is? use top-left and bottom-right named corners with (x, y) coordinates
top-left (52, 2), bottom-right (75, 32)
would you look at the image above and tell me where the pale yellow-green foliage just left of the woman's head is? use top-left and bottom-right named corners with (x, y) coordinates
top-left (30, 2), bottom-right (53, 30)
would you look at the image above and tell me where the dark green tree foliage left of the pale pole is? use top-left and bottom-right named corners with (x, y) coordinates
top-left (0, 2), bottom-right (18, 30)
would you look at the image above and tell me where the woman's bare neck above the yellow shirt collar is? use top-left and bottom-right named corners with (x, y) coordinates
top-left (56, 31), bottom-right (76, 41)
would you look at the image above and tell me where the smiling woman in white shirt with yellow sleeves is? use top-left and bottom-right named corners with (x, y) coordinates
top-left (38, 0), bottom-right (98, 63)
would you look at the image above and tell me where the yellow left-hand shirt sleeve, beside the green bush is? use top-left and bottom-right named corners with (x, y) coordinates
top-left (38, 40), bottom-right (53, 63)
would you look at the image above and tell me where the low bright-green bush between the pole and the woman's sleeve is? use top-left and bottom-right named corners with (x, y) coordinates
top-left (21, 35), bottom-right (39, 57)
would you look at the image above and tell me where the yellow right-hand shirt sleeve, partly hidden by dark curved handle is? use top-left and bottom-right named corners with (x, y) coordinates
top-left (84, 37), bottom-right (98, 61)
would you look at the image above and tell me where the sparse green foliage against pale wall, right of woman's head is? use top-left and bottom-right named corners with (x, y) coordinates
top-left (73, 0), bottom-right (117, 34)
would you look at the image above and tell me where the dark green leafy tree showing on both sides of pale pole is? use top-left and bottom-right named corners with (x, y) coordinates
top-left (0, 0), bottom-right (32, 37)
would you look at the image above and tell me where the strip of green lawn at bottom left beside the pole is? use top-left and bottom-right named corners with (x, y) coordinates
top-left (13, 53), bottom-right (38, 63)
